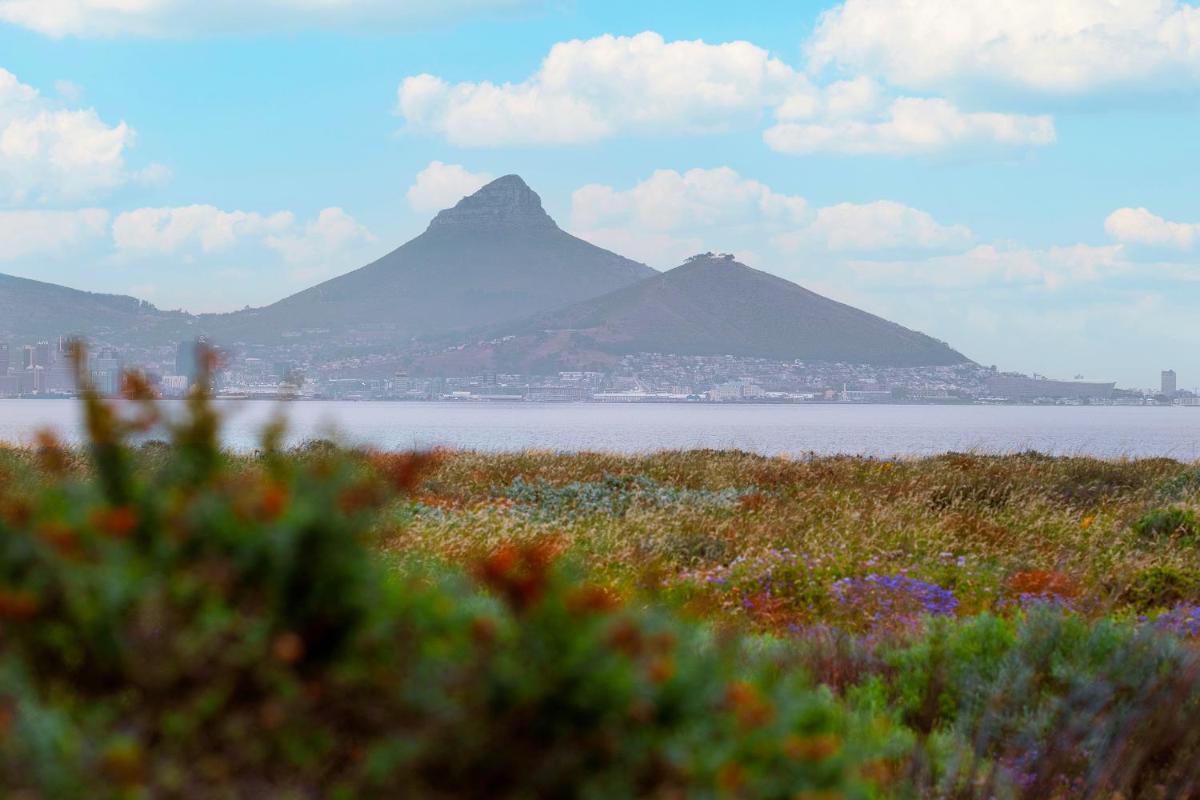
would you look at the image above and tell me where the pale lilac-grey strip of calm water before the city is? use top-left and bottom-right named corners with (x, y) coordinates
top-left (0, 399), bottom-right (1200, 461)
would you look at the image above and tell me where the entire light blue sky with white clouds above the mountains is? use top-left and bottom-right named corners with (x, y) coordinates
top-left (0, 0), bottom-right (1200, 386)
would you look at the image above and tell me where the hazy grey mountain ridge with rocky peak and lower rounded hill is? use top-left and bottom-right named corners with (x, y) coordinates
top-left (0, 175), bottom-right (968, 366)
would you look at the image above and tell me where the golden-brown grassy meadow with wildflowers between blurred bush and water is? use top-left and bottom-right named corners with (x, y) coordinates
top-left (398, 451), bottom-right (1200, 632)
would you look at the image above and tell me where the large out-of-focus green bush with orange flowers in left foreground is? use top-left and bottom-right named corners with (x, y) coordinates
top-left (0, 352), bottom-right (907, 799)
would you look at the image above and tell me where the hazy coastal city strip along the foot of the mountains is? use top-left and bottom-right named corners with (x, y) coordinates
top-left (0, 337), bottom-right (1200, 405)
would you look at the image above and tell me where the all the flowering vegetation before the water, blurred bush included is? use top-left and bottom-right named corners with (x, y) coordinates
top-left (0, 371), bottom-right (1200, 800)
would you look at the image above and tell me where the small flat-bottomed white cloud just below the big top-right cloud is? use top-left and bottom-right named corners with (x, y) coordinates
top-left (763, 92), bottom-right (1056, 156)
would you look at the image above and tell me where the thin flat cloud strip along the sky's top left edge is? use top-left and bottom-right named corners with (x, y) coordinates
top-left (0, 0), bottom-right (541, 37)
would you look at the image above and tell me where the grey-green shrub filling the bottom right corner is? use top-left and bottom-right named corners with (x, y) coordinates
top-left (874, 609), bottom-right (1200, 798)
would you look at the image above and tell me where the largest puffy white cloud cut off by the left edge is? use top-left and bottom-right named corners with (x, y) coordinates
top-left (0, 68), bottom-right (134, 203)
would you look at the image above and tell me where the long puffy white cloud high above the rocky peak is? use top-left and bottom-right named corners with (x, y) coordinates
top-left (397, 31), bottom-right (804, 146)
